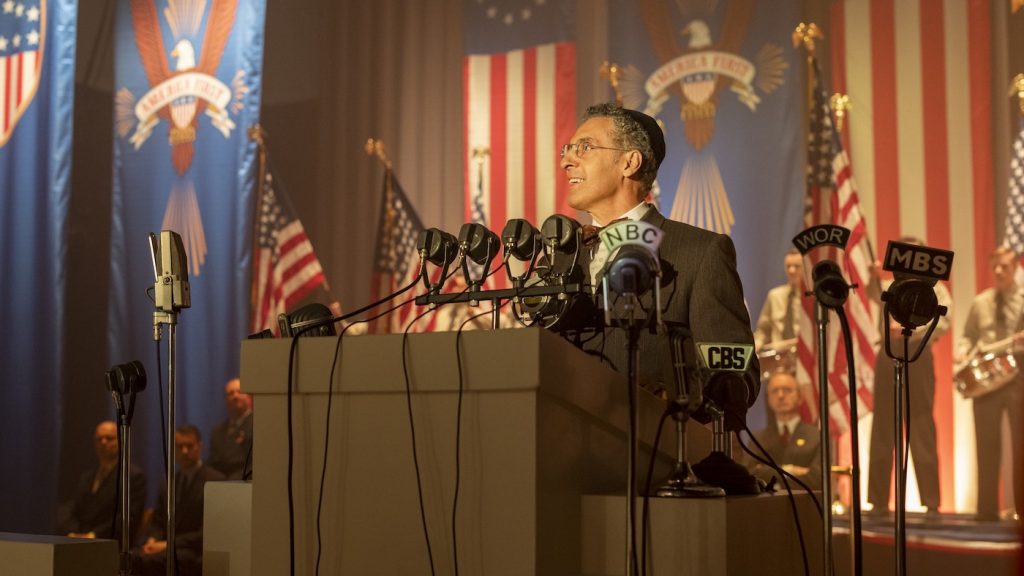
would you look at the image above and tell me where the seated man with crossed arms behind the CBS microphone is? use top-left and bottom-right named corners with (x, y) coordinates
top-left (750, 372), bottom-right (821, 490)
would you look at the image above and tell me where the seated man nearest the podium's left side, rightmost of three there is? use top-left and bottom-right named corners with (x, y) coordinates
top-left (207, 378), bottom-right (253, 480)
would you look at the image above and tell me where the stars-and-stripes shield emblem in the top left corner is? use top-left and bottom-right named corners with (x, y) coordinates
top-left (0, 0), bottom-right (46, 147)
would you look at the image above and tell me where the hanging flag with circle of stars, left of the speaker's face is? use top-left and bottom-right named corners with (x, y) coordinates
top-left (463, 0), bottom-right (577, 234)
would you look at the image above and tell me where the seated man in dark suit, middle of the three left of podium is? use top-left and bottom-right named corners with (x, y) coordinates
top-left (138, 424), bottom-right (224, 576)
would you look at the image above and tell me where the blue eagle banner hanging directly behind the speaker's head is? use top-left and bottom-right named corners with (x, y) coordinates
top-left (609, 0), bottom-right (804, 428)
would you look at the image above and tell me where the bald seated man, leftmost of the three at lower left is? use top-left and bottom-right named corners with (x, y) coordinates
top-left (57, 420), bottom-right (145, 542)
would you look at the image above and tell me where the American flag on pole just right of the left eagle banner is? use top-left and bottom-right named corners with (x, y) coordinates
top-left (251, 170), bottom-right (327, 332)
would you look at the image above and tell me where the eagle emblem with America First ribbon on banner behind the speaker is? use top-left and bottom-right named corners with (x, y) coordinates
top-left (620, 0), bottom-right (788, 234)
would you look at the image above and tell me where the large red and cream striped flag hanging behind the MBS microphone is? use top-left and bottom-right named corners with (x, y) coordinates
top-left (822, 0), bottom-right (995, 511)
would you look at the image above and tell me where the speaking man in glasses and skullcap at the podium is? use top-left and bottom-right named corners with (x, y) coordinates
top-left (561, 104), bottom-right (760, 413)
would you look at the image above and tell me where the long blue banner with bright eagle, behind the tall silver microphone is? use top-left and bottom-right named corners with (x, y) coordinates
top-left (108, 0), bottom-right (265, 487)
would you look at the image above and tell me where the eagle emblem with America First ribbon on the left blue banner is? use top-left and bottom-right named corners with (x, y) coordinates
top-left (116, 0), bottom-right (248, 275)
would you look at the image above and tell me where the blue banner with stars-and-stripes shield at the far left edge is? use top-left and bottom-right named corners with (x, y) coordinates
top-left (0, 0), bottom-right (77, 532)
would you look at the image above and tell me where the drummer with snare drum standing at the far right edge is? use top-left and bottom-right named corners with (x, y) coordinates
top-left (956, 247), bottom-right (1024, 521)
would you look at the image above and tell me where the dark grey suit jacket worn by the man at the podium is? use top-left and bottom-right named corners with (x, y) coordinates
top-left (581, 207), bottom-right (761, 422)
